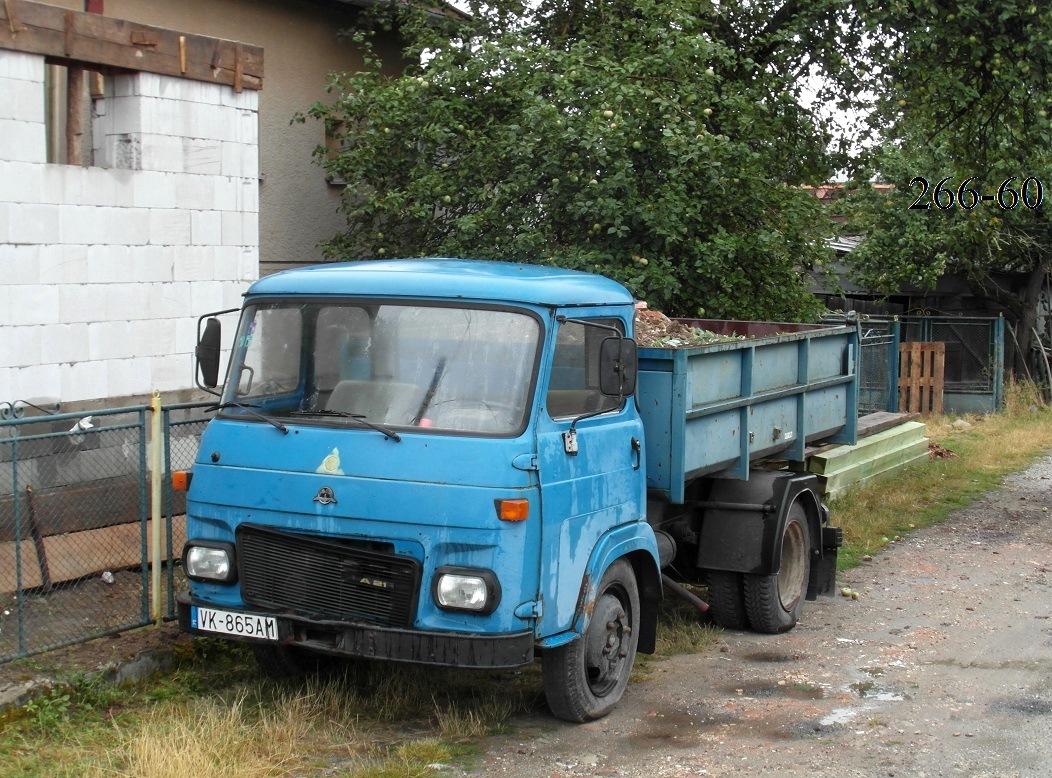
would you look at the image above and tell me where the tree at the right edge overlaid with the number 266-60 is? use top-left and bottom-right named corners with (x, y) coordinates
top-left (852, 0), bottom-right (1052, 369)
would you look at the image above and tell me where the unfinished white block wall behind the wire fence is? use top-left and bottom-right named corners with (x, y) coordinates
top-left (0, 49), bottom-right (259, 404)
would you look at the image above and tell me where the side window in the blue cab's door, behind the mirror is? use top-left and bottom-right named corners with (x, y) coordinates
top-left (545, 319), bottom-right (624, 418)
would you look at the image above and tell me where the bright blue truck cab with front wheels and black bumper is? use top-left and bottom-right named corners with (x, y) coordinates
top-left (178, 259), bottom-right (661, 721)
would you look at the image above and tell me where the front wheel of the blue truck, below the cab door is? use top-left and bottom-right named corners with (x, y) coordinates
top-left (542, 559), bottom-right (640, 722)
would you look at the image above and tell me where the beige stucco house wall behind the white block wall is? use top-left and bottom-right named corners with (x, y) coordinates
top-left (45, 0), bottom-right (397, 274)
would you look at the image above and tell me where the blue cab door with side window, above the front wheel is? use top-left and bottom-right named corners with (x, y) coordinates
top-left (537, 311), bottom-right (646, 637)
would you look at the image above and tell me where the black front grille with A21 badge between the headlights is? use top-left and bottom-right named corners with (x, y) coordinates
top-left (237, 525), bottom-right (421, 627)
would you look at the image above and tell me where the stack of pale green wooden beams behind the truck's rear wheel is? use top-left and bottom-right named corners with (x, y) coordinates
top-left (801, 422), bottom-right (928, 498)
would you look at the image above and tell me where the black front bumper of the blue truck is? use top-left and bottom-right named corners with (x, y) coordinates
top-left (176, 592), bottom-right (533, 670)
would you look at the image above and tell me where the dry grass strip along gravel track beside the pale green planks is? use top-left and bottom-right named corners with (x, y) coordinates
top-left (830, 384), bottom-right (1052, 569)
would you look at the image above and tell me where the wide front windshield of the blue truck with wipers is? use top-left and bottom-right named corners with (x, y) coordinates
top-left (223, 301), bottom-right (541, 435)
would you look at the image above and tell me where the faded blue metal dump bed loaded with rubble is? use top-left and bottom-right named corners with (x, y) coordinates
top-left (639, 320), bottom-right (858, 503)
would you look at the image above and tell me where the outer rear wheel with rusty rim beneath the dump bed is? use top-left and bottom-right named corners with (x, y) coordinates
top-left (745, 501), bottom-right (811, 634)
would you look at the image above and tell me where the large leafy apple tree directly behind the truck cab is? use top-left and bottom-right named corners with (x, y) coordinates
top-left (310, 0), bottom-right (862, 320)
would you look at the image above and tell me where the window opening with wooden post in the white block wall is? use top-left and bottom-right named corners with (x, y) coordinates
top-left (44, 62), bottom-right (103, 165)
